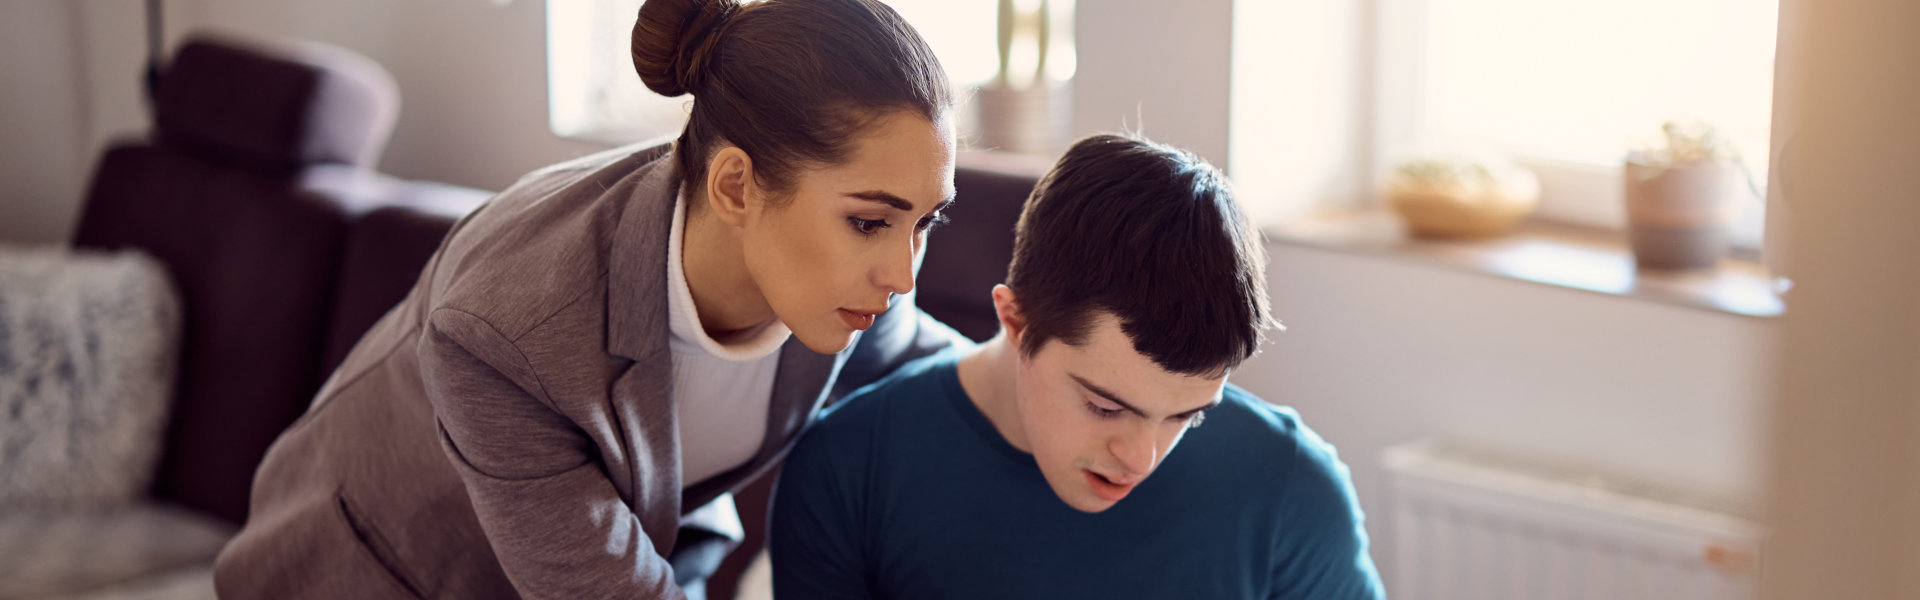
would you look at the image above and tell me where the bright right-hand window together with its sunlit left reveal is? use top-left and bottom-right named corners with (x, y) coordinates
top-left (1233, 0), bottom-right (1778, 246)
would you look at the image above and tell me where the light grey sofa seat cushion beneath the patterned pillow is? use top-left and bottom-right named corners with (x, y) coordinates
top-left (0, 504), bottom-right (234, 598)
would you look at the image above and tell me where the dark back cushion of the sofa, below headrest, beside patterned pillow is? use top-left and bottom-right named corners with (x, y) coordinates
top-left (73, 146), bottom-right (346, 523)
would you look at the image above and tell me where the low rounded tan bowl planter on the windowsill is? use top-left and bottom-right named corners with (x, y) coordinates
top-left (1386, 156), bottom-right (1540, 238)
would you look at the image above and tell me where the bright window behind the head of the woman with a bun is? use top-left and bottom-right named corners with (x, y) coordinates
top-left (547, 0), bottom-right (1006, 144)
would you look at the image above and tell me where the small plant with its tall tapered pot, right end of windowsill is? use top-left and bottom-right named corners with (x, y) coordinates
top-left (1624, 123), bottom-right (1751, 269)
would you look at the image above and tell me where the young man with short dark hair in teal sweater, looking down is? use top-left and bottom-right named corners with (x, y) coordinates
top-left (772, 137), bottom-right (1382, 600)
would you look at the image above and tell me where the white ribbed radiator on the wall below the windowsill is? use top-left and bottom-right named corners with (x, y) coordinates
top-left (1384, 442), bottom-right (1761, 600)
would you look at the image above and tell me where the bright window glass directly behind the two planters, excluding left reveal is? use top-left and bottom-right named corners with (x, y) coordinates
top-left (1371, 0), bottom-right (1780, 248)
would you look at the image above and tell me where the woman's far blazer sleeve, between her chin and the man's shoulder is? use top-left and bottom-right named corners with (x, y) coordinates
top-left (831, 292), bottom-right (972, 402)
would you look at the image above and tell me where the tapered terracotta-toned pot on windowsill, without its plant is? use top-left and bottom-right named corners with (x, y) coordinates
top-left (1624, 160), bottom-right (1743, 269)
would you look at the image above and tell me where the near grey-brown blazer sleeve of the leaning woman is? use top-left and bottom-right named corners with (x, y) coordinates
top-left (419, 308), bottom-right (685, 600)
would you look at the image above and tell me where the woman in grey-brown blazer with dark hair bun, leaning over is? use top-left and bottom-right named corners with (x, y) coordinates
top-left (215, 0), bottom-right (958, 598)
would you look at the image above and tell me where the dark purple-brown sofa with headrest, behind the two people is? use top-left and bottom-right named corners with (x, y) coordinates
top-left (73, 37), bottom-right (1044, 598)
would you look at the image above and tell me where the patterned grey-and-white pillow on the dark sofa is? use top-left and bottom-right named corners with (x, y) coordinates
top-left (0, 246), bottom-right (180, 510)
